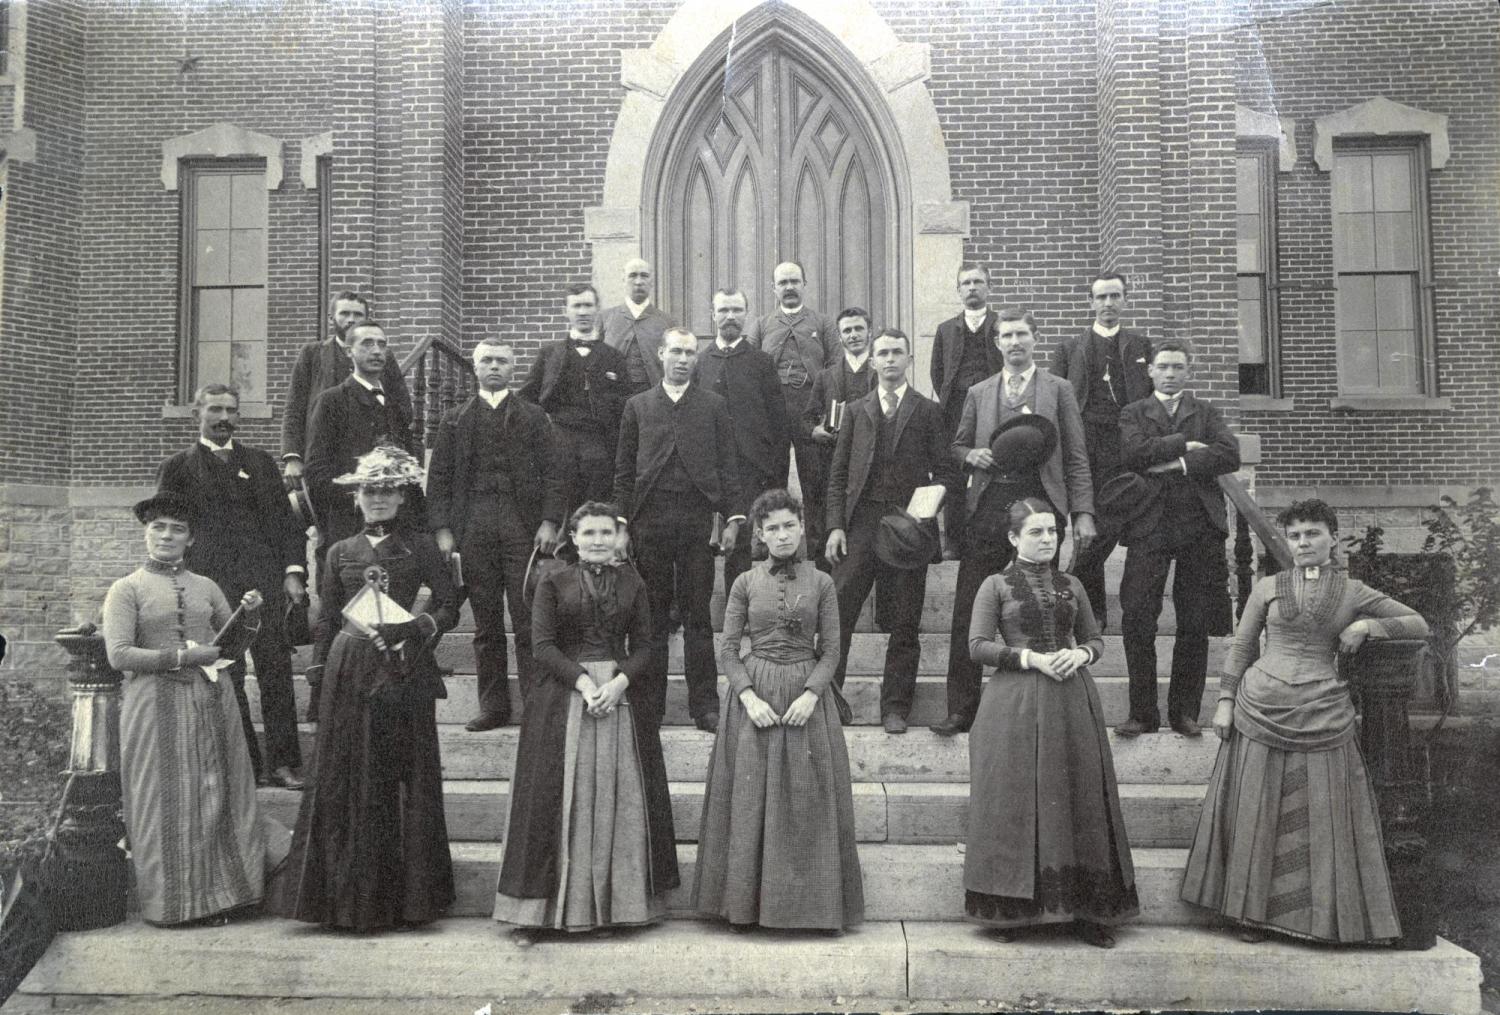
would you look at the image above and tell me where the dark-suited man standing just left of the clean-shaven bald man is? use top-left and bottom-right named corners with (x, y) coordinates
top-left (518, 285), bottom-right (632, 511)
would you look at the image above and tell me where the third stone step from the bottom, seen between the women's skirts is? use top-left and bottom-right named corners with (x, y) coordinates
top-left (260, 780), bottom-right (1206, 847)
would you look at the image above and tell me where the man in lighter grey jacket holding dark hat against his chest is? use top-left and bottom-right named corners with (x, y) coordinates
top-left (932, 307), bottom-right (1095, 736)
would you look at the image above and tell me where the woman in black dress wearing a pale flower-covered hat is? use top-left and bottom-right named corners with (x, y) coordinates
top-left (278, 447), bottom-right (458, 931)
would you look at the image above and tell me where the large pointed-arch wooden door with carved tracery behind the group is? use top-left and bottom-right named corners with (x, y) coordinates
top-left (647, 31), bottom-right (899, 337)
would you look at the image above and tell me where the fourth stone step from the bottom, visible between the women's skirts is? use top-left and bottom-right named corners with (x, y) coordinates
top-left (276, 724), bottom-right (1218, 786)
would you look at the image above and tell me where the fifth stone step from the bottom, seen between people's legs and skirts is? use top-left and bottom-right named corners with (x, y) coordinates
top-left (246, 673), bottom-right (1218, 726)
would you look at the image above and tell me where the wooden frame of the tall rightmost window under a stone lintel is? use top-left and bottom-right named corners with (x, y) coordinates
top-left (1328, 133), bottom-right (1439, 403)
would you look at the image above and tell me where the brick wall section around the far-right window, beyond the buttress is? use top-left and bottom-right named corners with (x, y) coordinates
top-left (1227, 0), bottom-right (1500, 486)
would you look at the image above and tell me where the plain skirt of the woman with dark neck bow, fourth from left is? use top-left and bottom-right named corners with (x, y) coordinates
top-left (693, 655), bottom-right (864, 930)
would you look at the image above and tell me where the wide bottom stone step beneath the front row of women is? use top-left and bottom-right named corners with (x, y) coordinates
top-left (17, 918), bottom-right (1481, 1015)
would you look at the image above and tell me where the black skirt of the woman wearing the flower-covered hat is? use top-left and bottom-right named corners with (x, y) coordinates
top-left (275, 633), bottom-right (455, 931)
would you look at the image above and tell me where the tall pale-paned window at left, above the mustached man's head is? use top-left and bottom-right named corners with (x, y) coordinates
top-left (179, 159), bottom-right (267, 405)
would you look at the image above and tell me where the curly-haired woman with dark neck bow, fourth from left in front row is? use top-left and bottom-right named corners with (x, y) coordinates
top-left (693, 490), bottom-right (864, 931)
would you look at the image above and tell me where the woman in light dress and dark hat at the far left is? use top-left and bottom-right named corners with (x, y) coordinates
top-left (104, 493), bottom-right (267, 925)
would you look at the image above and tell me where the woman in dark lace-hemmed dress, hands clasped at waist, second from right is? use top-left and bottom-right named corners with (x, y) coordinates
top-left (963, 498), bottom-right (1140, 948)
